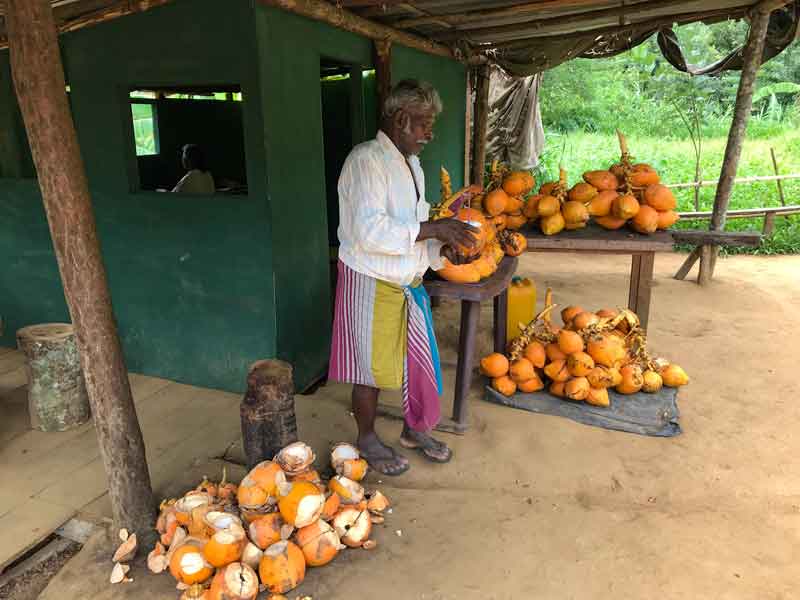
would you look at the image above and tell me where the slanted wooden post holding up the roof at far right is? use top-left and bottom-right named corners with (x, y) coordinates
top-left (697, 9), bottom-right (769, 285)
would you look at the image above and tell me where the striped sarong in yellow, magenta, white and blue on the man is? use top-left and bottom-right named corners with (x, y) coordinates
top-left (328, 261), bottom-right (442, 431)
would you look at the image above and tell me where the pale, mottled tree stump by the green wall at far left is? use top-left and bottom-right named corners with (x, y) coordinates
top-left (17, 323), bottom-right (91, 431)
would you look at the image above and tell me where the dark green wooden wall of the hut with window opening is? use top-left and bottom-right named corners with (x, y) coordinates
top-left (0, 0), bottom-right (465, 390)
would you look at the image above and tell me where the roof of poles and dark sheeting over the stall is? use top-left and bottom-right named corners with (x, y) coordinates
top-left (0, 0), bottom-right (798, 72)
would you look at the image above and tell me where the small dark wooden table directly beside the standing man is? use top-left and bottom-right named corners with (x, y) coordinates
top-left (425, 256), bottom-right (518, 433)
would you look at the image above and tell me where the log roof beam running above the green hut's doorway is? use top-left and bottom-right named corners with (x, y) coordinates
top-left (257, 0), bottom-right (455, 58)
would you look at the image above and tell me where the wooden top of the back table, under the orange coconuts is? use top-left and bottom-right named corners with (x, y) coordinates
top-left (520, 223), bottom-right (673, 253)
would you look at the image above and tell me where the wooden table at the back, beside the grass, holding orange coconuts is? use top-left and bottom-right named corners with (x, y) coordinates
top-left (520, 223), bottom-right (673, 329)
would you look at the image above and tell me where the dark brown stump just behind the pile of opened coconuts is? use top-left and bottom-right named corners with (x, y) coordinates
top-left (239, 360), bottom-right (297, 469)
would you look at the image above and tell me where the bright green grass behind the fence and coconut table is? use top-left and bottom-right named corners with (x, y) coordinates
top-left (537, 130), bottom-right (800, 254)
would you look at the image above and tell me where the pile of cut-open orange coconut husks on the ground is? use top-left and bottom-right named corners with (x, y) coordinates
top-left (112, 442), bottom-right (391, 600)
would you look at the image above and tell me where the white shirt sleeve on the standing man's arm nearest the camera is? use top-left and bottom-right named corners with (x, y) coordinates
top-left (338, 154), bottom-right (420, 255)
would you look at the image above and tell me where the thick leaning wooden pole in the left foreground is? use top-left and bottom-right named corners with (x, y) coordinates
top-left (6, 0), bottom-right (155, 543)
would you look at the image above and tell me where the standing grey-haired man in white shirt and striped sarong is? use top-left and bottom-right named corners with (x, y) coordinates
top-left (329, 80), bottom-right (475, 475)
